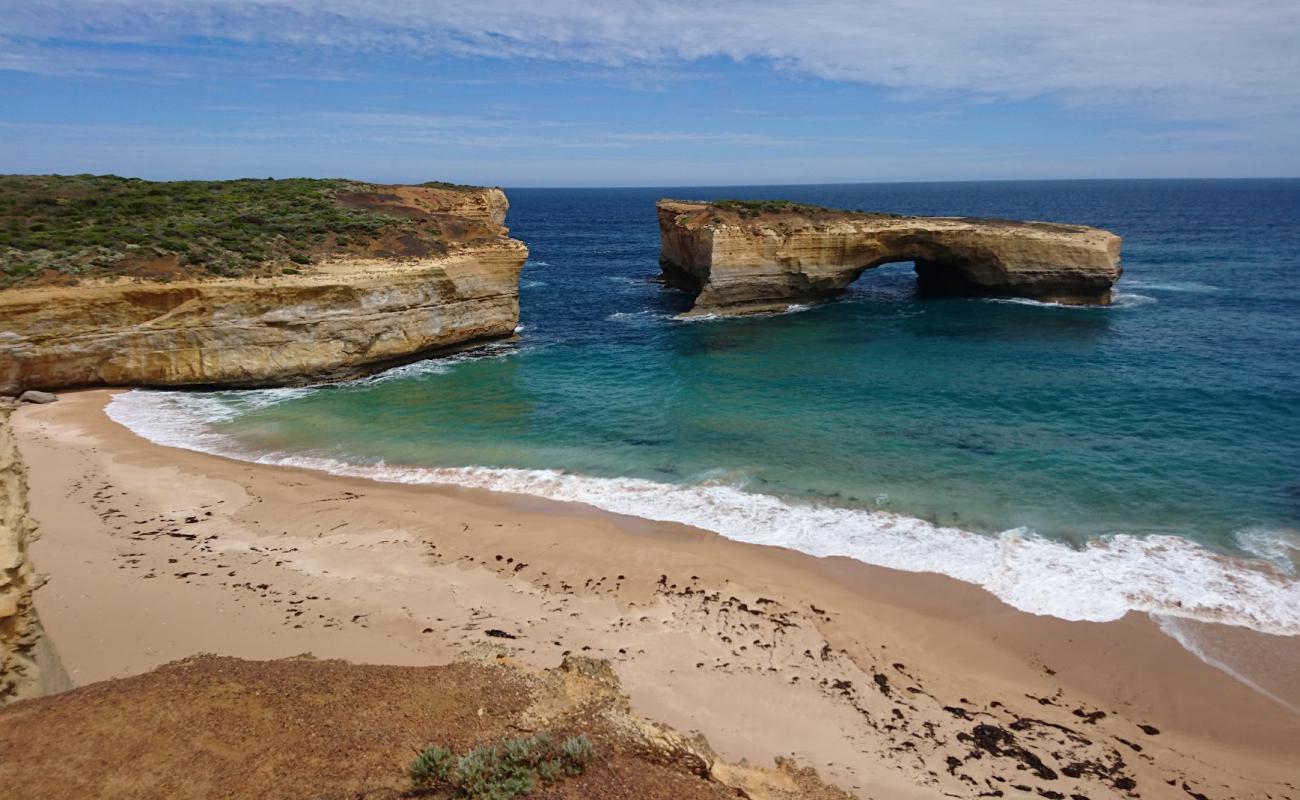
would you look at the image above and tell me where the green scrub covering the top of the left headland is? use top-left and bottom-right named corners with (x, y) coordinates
top-left (0, 174), bottom-right (478, 286)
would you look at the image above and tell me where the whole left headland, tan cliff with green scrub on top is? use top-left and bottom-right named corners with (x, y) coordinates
top-left (0, 177), bottom-right (528, 394)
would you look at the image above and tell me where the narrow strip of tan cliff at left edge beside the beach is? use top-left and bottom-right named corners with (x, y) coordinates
top-left (0, 399), bottom-right (66, 705)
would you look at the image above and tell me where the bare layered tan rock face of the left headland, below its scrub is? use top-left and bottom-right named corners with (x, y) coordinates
top-left (0, 187), bottom-right (528, 394)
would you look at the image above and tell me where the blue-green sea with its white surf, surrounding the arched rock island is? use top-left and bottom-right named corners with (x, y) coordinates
top-left (111, 180), bottom-right (1300, 633)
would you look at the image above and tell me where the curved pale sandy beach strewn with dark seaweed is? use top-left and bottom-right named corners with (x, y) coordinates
top-left (14, 390), bottom-right (1300, 797)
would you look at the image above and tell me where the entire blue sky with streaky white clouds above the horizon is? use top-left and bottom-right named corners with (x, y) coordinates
top-left (0, 0), bottom-right (1300, 187)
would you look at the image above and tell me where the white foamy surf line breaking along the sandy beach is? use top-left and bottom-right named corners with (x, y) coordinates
top-left (107, 390), bottom-right (1300, 635)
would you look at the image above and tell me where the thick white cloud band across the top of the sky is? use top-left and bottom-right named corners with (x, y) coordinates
top-left (0, 0), bottom-right (1300, 118)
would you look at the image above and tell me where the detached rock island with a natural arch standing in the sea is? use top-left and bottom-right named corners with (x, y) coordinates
top-left (658, 200), bottom-right (1121, 315)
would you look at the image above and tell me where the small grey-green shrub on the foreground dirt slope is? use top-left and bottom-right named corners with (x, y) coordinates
top-left (407, 731), bottom-right (594, 800)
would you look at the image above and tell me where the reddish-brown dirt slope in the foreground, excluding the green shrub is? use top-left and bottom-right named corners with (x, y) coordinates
top-left (0, 654), bottom-right (848, 800)
